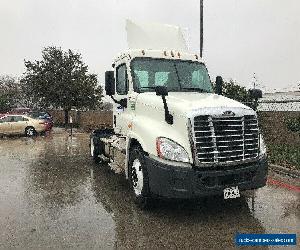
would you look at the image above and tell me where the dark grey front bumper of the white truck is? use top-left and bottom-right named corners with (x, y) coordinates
top-left (145, 157), bottom-right (268, 199)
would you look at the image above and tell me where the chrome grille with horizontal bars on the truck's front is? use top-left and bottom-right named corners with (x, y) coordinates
top-left (193, 115), bottom-right (259, 164)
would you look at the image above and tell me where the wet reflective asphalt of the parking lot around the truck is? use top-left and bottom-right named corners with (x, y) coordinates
top-left (0, 133), bottom-right (300, 249)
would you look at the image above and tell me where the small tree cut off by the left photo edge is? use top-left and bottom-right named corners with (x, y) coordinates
top-left (0, 75), bottom-right (23, 112)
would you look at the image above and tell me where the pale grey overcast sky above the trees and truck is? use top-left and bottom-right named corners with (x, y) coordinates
top-left (0, 0), bottom-right (300, 92)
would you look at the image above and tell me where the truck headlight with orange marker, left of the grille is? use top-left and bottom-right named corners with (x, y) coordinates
top-left (156, 137), bottom-right (189, 162)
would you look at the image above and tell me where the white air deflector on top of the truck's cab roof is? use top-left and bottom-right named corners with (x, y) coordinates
top-left (126, 20), bottom-right (188, 52)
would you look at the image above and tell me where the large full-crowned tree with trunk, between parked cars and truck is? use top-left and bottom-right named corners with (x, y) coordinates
top-left (21, 47), bottom-right (102, 124)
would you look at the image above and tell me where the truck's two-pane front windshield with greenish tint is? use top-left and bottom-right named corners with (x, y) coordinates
top-left (131, 58), bottom-right (212, 93)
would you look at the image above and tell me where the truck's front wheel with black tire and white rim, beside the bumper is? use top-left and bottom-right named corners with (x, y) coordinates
top-left (128, 146), bottom-right (152, 209)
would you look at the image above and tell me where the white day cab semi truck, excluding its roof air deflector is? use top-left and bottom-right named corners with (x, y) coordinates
top-left (90, 19), bottom-right (268, 208)
